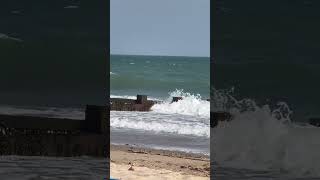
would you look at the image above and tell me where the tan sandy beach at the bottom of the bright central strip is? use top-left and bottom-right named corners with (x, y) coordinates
top-left (110, 145), bottom-right (210, 180)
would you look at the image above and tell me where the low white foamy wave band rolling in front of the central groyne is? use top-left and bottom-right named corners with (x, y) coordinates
top-left (110, 111), bottom-right (210, 138)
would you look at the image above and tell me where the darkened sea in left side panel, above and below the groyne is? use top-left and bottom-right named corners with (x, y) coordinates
top-left (0, 0), bottom-right (109, 180)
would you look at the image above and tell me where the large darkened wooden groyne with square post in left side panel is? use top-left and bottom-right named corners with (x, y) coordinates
top-left (0, 105), bottom-right (110, 157)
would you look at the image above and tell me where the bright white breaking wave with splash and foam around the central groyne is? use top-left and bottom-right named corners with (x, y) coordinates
top-left (110, 90), bottom-right (210, 138)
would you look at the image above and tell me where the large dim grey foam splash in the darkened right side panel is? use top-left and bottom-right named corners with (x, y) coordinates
top-left (211, 88), bottom-right (320, 176)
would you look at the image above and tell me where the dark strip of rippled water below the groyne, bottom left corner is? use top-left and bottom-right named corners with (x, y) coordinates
top-left (0, 155), bottom-right (109, 180)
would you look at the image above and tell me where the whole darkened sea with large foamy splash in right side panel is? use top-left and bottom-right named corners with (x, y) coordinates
top-left (210, 0), bottom-right (320, 180)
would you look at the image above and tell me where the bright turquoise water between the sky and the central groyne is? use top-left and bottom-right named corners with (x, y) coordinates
top-left (110, 55), bottom-right (210, 98)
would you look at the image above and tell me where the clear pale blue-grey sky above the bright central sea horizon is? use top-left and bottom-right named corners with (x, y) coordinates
top-left (110, 0), bottom-right (210, 57)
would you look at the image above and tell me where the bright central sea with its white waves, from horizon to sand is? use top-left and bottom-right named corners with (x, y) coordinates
top-left (110, 55), bottom-right (210, 155)
